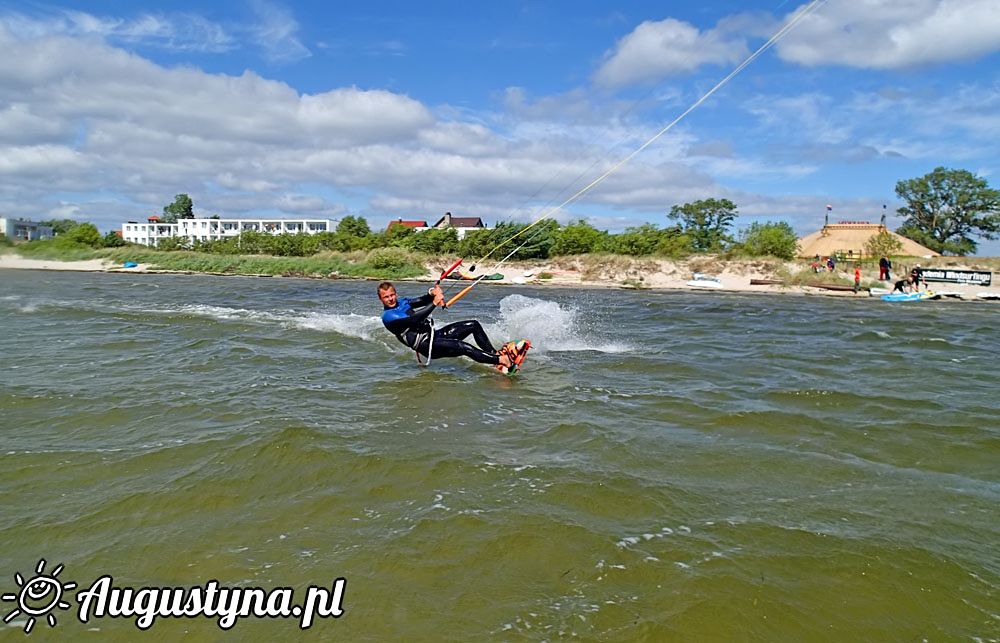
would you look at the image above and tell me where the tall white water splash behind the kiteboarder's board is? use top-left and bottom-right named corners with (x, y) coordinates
top-left (487, 295), bottom-right (633, 353)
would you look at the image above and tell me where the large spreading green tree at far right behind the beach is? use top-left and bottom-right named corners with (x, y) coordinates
top-left (896, 167), bottom-right (1000, 255)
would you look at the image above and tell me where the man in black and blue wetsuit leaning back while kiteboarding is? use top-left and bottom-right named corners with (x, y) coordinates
top-left (378, 281), bottom-right (511, 373)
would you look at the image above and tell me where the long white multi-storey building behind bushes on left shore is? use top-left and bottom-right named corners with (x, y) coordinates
top-left (122, 216), bottom-right (334, 246)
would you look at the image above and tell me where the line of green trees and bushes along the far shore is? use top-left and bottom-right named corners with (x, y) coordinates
top-left (33, 167), bottom-right (1000, 259)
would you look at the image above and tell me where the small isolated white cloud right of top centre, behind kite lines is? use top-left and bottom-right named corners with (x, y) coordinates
top-left (594, 18), bottom-right (748, 89)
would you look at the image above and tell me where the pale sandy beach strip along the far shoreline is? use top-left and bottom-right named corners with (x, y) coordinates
top-left (0, 252), bottom-right (1000, 301)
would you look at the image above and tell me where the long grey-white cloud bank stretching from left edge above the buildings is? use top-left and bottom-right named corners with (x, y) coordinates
top-left (0, 18), bottom-right (836, 236)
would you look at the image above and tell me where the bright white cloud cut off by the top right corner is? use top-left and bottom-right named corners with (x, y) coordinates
top-left (777, 0), bottom-right (1000, 69)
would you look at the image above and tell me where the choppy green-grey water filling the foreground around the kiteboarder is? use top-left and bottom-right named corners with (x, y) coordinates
top-left (0, 271), bottom-right (1000, 641)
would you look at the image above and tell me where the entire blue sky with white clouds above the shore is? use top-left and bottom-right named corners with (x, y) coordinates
top-left (0, 0), bottom-right (1000, 255)
